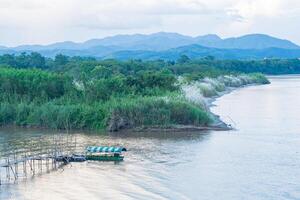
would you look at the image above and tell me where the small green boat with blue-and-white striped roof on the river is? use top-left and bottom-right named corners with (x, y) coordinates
top-left (86, 146), bottom-right (127, 162)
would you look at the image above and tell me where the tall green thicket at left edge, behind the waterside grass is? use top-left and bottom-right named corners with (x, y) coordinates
top-left (0, 68), bottom-right (73, 100)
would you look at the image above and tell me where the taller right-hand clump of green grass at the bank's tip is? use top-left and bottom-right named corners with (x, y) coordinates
top-left (108, 97), bottom-right (211, 130)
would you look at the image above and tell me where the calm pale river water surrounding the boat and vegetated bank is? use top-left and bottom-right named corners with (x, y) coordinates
top-left (0, 76), bottom-right (300, 200)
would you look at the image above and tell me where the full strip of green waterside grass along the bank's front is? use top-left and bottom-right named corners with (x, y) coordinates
top-left (0, 96), bottom-right (211, 131)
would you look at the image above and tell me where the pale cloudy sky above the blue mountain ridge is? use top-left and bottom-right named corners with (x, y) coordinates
top-left (0, 0), bottom-right (300, 46)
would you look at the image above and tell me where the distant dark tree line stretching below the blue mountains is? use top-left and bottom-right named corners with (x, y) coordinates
top-left (0, 52), bottom-right (300, 76)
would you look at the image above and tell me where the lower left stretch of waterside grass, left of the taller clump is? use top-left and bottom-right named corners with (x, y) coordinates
top-left (0, 102), bottom-right (105, 129)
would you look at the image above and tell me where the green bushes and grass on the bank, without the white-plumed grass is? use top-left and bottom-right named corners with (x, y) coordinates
top-left (0, 67), bottom-right (209, 130)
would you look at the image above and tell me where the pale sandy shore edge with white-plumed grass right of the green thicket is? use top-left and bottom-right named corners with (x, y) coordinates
top-left (179, 74), bottom-right (270, 131)
